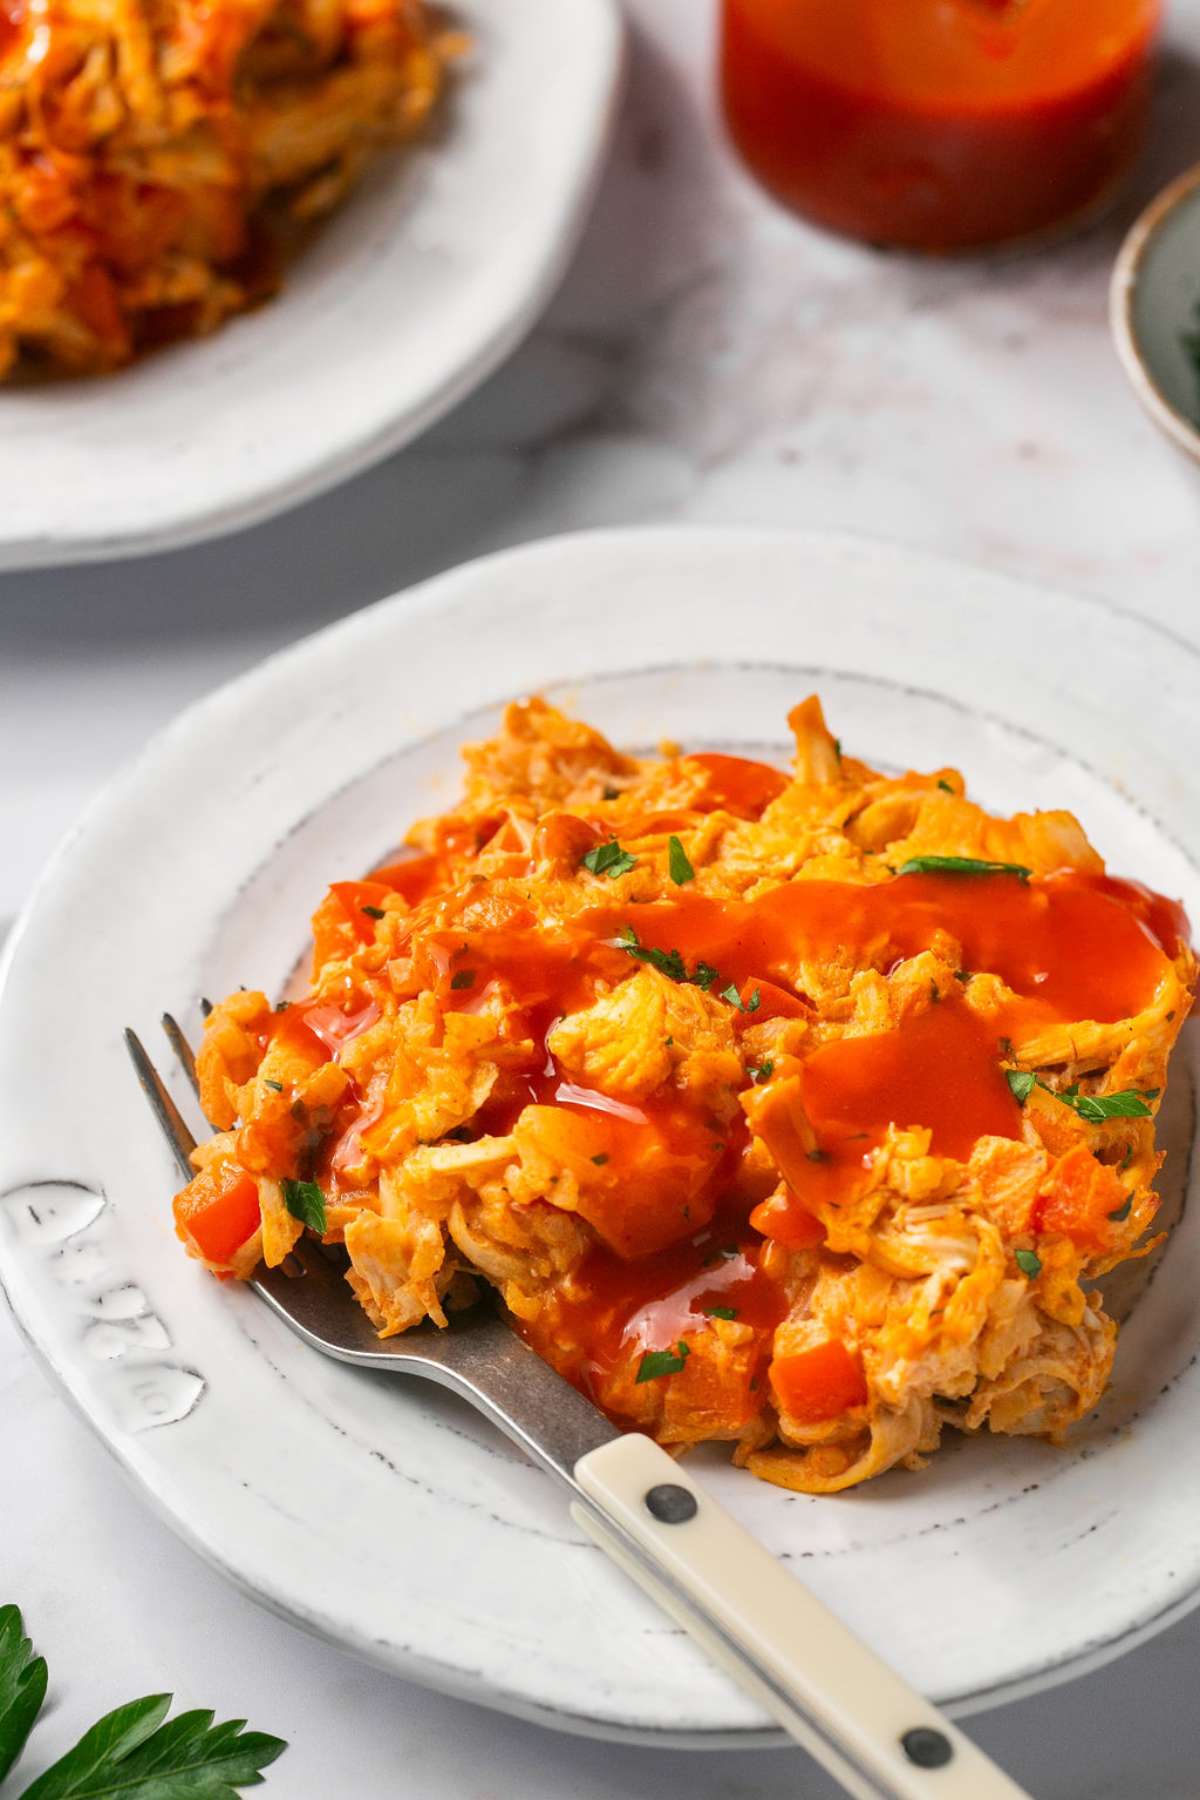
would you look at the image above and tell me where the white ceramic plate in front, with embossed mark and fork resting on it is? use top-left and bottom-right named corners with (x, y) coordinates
top-left (0, 531), bottom-right (1200, 1742)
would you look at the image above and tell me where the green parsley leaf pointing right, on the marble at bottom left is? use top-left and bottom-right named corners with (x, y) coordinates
top-left (23, 1694), bottom-right (288, 1800)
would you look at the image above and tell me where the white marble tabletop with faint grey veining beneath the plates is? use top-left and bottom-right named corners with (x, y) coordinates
top-left (0, 0), bottom-right (1200, 1800)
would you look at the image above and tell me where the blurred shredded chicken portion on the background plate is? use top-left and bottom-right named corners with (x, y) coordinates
top-left (0, 0), bottom-right (459, 376)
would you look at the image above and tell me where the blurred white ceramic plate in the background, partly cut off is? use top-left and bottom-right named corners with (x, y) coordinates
top-left (0, 0), bottom-right (621, 569)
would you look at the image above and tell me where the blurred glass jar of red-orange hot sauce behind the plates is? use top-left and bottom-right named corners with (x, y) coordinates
top-left (721, 0), bottom-right (1162, 252)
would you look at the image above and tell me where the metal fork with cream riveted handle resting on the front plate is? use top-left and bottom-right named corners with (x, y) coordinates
top-left (126, 1013), bottom-right (1027, 1800)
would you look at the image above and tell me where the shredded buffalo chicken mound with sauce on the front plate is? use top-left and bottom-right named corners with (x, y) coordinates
top-left (175, 698), bottom-right (1196, 1494)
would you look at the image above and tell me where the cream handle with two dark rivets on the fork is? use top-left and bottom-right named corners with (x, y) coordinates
top-left (572, 1433), bottom-right (1027, 1800)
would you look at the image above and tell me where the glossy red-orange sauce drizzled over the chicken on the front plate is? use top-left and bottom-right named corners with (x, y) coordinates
top-left (284, 756), bottom-right (1187, 1411)
